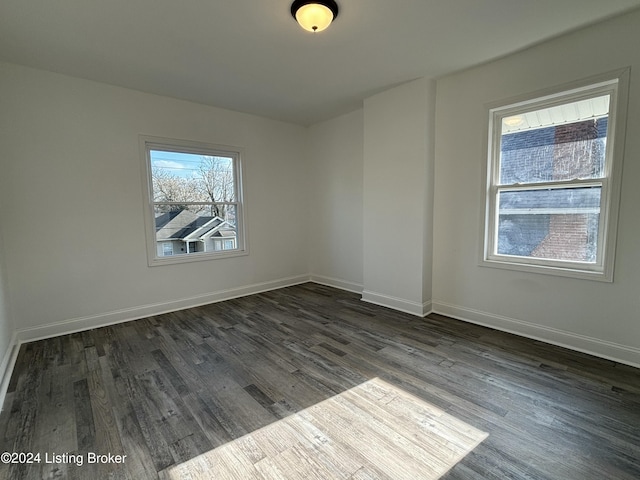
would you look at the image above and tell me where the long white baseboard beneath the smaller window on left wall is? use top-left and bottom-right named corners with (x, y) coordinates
top-left (11, 275), bottom-right (309, 343)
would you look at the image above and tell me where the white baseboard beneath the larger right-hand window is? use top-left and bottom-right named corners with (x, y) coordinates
top-left (433, 301), bottom-right (640, 368)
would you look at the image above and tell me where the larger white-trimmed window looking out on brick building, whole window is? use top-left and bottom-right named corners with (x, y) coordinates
top-left (482, 70), bottom-right (628, 281)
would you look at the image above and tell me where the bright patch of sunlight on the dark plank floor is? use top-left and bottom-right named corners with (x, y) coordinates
top-left (160, 378), bottom-right (488, 480)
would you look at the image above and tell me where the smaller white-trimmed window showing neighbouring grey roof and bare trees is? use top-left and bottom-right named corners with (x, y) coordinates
top-left (140, 137), bottom-right (246, 266)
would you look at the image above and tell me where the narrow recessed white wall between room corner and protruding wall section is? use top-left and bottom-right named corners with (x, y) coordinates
top-left (308, 110), bottom-right (364, 291)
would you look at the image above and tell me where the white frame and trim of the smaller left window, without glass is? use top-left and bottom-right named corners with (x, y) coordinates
top-left (139, 135), bottom-right (249, 267)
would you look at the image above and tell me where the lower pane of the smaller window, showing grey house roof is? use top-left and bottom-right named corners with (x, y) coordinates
top-left (155, 204), bottom-right (238, 257)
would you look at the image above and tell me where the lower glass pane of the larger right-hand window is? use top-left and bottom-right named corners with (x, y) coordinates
top-left (496, 187), bottom-right (601, 263)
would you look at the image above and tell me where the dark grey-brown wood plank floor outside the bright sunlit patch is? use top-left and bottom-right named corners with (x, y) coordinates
top-left (0, 283), bottom-right (640, 480)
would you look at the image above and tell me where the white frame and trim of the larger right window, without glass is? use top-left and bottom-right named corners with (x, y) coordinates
top-left (480, 68), bottom-right (629, 282)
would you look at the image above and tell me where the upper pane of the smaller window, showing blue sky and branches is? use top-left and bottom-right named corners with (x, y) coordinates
top-left (150, 150), bottom-right (236, 202)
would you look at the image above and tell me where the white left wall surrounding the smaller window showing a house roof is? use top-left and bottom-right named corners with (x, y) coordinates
top-left (0, 64), bottom-right (309, 338)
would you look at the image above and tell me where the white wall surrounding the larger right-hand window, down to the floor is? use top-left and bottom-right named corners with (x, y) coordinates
top-left (433, 11), bottom-right (640, 365)
